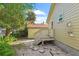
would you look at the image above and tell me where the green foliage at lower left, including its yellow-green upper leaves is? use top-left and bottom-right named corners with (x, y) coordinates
top-left (0, 36), bottom-right (16, 56)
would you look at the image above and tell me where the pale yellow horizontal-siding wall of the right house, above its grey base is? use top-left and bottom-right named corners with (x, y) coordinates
top-left (51, 3), bottom-right (79, 50)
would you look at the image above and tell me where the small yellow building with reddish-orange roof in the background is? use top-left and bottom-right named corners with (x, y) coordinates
top-left (27, 24), bottom-right (48, 38)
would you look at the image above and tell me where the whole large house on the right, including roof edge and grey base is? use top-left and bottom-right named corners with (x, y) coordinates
top-left (47, 3), bottom-right (79, 55)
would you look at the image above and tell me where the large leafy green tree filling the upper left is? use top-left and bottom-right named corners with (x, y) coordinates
top-left (0, 3), bottom-right (33, 35)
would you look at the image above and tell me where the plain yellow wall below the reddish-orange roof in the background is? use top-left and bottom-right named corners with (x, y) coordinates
top-left (28, 27), bottom-right (48, 38)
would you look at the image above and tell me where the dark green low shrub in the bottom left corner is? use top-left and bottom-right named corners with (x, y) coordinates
top-left (0, 43), bottom-right (16, 56)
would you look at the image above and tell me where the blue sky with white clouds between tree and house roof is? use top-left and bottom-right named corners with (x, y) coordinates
top-left (34, 3), bottom-right (51, 24)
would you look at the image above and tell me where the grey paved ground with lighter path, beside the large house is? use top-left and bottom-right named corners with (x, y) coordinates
top-left (13, 40), bottom-right (70, 56)
